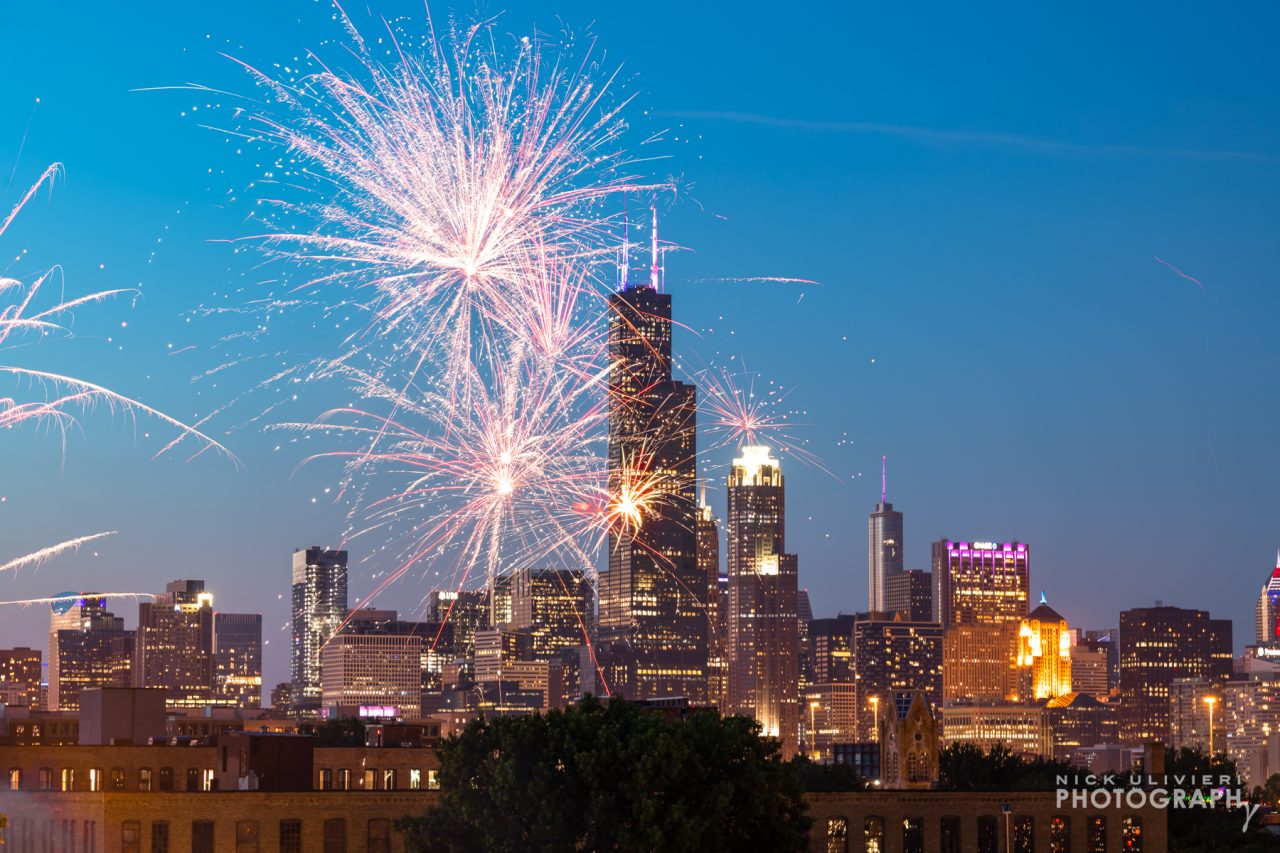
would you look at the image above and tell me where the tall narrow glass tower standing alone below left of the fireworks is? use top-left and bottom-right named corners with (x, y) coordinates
top-left (291, 546), bottom-right (347, 710)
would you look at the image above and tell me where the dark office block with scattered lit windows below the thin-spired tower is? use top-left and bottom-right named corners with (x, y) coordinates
top-left (852, 613), bottom-right (942, 742)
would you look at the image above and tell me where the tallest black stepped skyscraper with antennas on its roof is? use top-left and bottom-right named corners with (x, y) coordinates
top-left (598, 224), bottom-right (707, 702)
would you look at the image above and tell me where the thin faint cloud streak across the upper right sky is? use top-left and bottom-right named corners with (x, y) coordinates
top-left (654, 110), bottom-right (1280, 163)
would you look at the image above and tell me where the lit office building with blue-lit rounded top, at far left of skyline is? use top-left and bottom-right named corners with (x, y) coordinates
top-left (49, 593), bottom-right (137, 711)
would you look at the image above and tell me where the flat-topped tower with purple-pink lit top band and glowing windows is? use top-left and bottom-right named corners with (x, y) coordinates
top-left (932, 539), bottom-right (1030, 628)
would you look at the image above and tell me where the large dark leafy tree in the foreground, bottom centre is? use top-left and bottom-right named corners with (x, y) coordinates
top-left (398, 697), bottom-right (809, 853)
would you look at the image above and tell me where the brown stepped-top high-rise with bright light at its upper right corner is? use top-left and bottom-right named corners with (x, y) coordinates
top-left (133, 580), bottom-right (214, 708)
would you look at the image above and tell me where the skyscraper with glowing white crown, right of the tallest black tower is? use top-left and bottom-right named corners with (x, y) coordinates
top-left (728, 446), bottom-right (800, 754)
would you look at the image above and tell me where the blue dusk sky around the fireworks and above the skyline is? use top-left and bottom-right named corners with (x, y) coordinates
top-left (0, 0), bottom-right (1280, 683)
